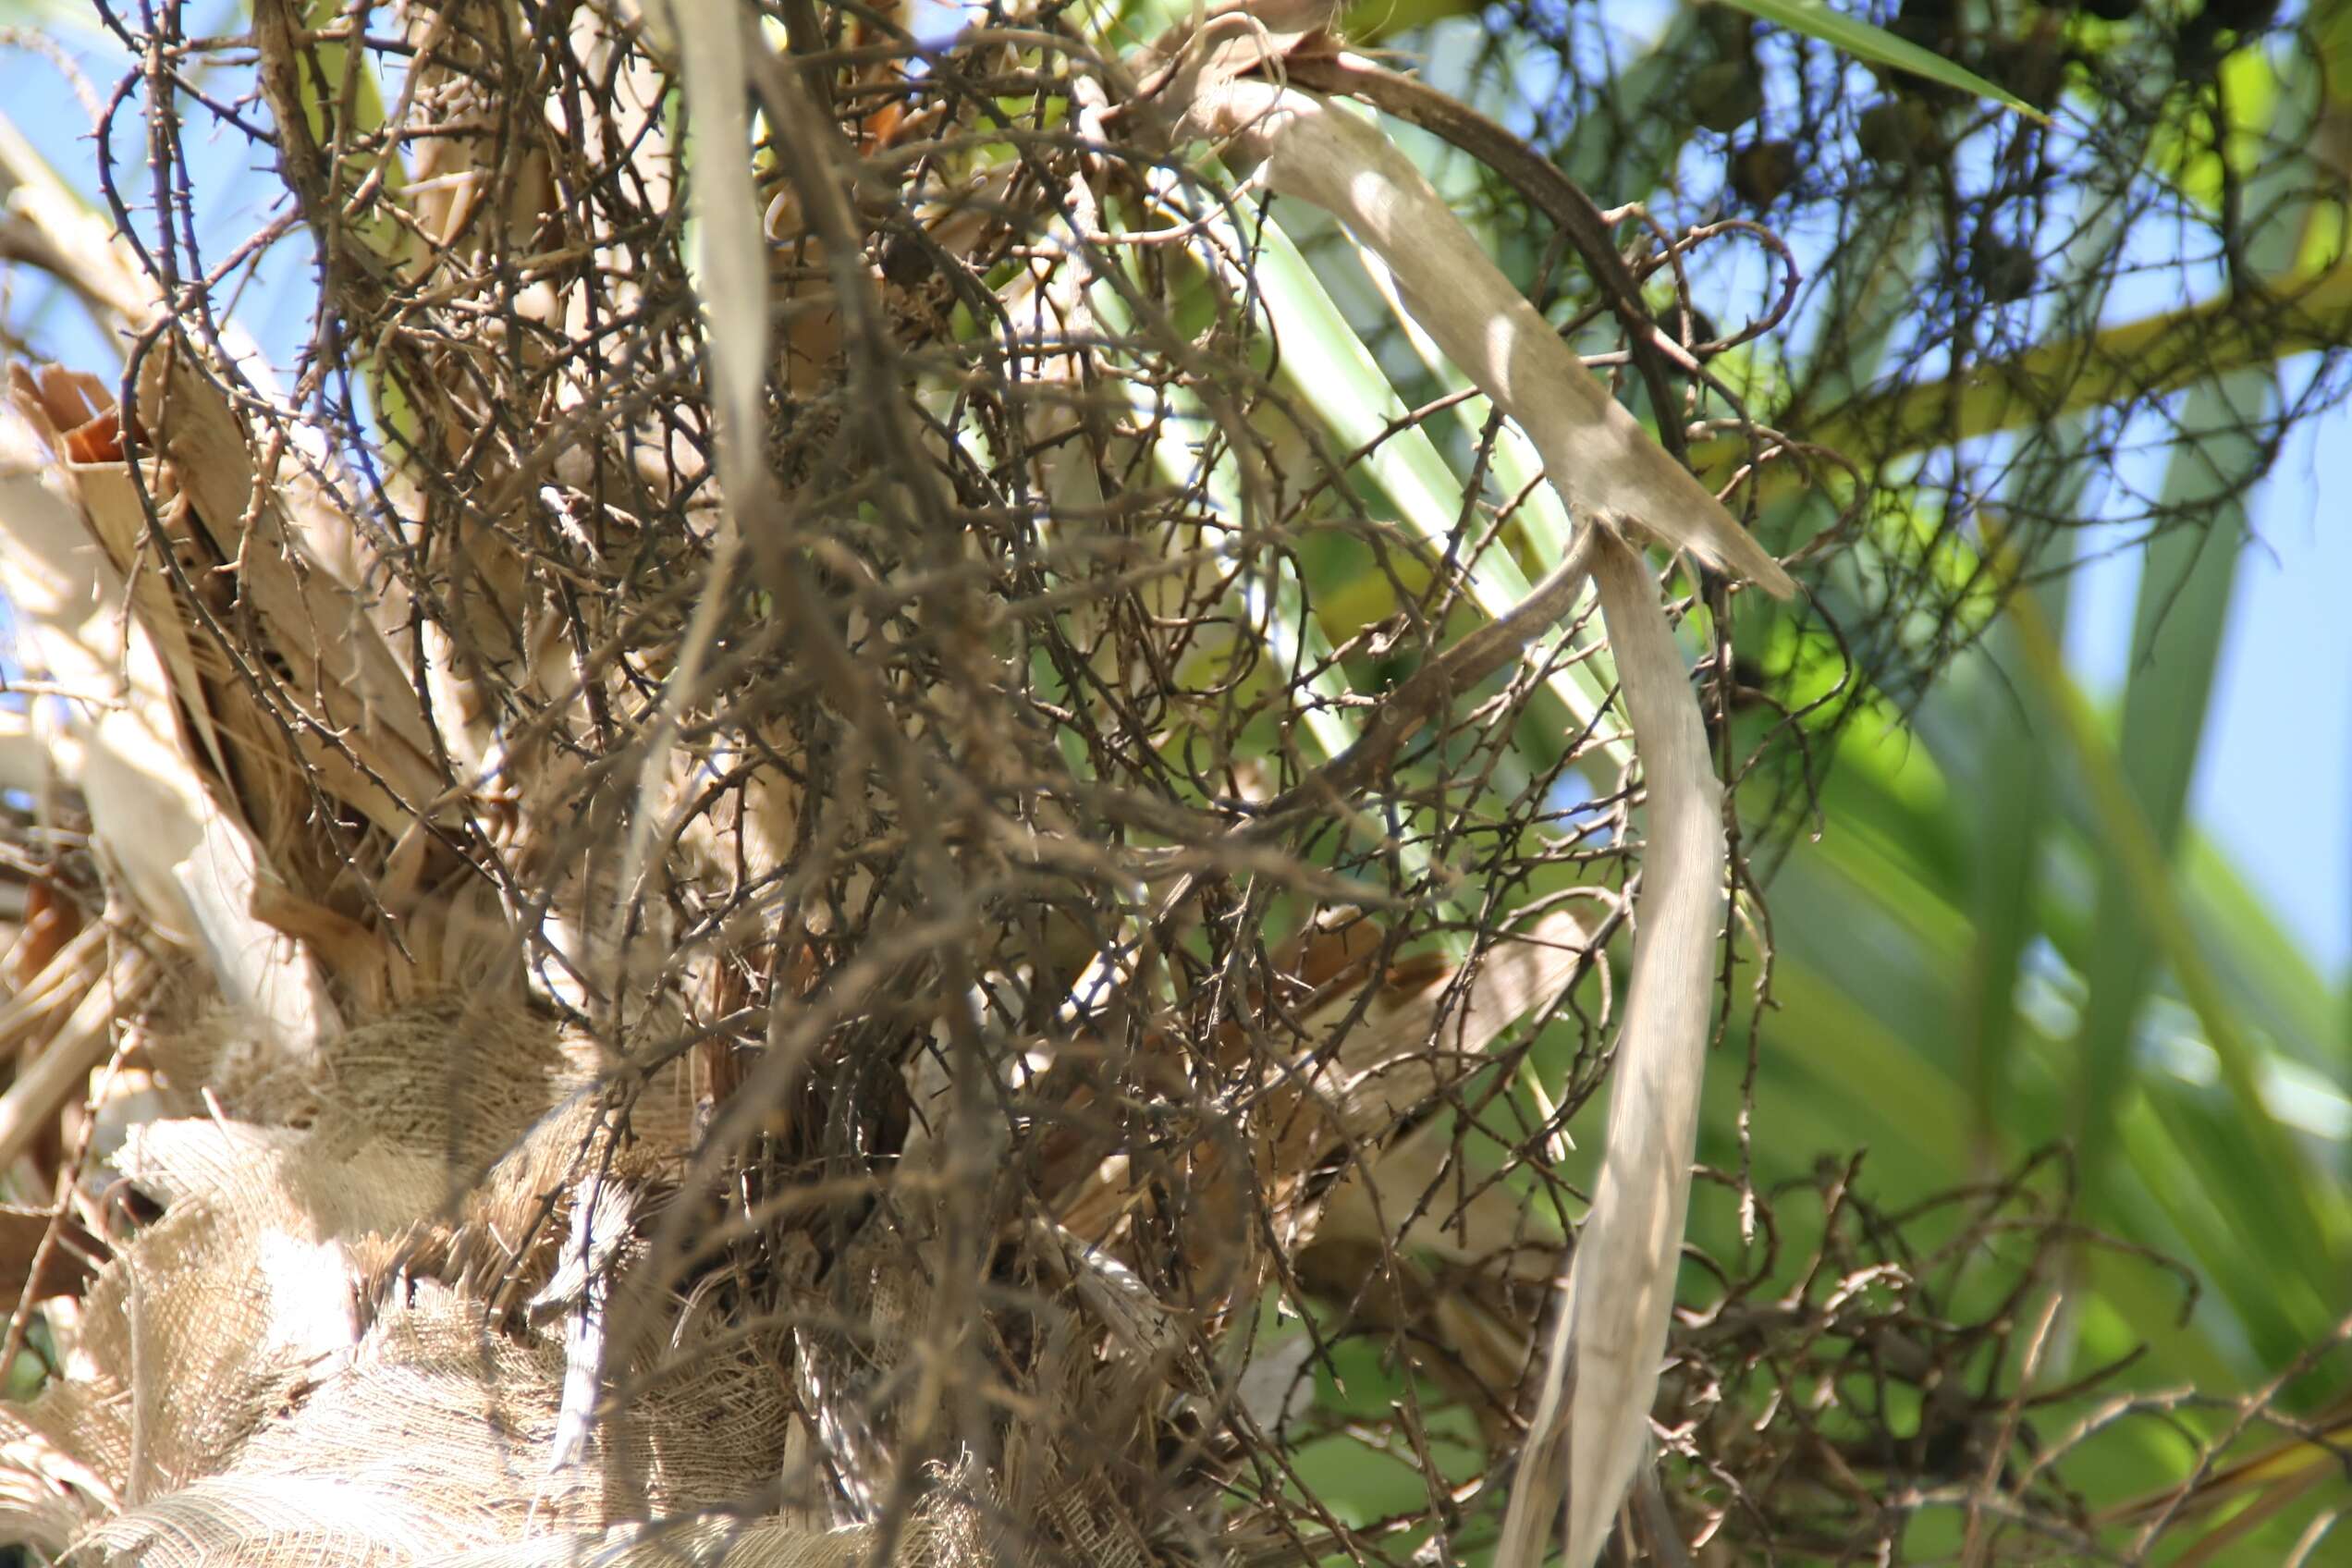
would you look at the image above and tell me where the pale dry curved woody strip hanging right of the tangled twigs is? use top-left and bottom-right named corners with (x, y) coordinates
top-left (1157, 80), bottom-right (1795, 1568)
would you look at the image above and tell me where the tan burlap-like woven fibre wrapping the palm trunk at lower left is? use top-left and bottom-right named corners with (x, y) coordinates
top-left (0, 1001), bottom-right (1185, 1568)
